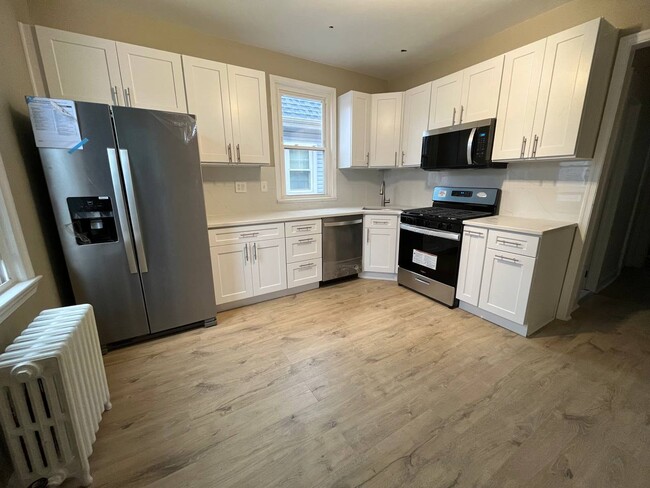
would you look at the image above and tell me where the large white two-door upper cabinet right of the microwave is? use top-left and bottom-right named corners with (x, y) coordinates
top-left (492, 19), bottom-right (618, 160)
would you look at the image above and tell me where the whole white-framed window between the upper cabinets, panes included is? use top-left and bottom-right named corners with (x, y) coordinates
top-left (271, 76), bottom-right (336, 202)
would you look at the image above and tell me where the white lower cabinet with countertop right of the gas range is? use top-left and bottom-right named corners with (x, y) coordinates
top-left (456, 221), bottom-right (576, 336)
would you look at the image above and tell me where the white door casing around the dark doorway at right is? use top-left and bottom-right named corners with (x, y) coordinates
top-left (557, 29), bottom-right (650, 320)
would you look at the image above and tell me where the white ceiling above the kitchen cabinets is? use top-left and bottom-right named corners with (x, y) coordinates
top-left (101, 0), bottom-right (568, 79)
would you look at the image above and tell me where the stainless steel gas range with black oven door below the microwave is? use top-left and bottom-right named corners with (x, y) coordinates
top-left (397, 186), bottom-right (501, 307)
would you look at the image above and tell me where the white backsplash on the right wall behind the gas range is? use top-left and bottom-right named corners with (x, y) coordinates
top-left (385, 161), bottom-right (592, 222)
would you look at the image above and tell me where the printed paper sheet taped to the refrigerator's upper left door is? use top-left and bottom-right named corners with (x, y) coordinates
top-left (27, 97), bottom-right (82, 149)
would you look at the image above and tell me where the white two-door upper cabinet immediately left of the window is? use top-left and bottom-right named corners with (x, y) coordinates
top-left (183, 56), bottom-right (271, 165)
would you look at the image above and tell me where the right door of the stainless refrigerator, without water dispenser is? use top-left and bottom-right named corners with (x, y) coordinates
top-left (113, 107), bottom-right (216, 332)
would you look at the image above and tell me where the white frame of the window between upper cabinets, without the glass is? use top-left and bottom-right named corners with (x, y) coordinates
top-left (269, 75), bottom-right (337, 203)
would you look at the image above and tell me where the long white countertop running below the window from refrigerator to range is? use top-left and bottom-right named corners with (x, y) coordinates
top-left (208, 207), bottom-right (402, 229)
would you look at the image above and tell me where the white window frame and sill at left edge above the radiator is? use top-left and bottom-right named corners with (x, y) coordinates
top-left (0, 150), bottom-right (41, 324)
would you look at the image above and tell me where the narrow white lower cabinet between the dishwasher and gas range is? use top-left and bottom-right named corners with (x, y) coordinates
top-left (363, 214), bottom-right (398, 275)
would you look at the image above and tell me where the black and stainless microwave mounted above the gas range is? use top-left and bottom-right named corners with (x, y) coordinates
top-left (420, 119), bottom-right (506, 171)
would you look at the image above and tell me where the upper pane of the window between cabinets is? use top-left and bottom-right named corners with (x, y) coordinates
top-left (281, 95), bottom-right (323, 147)
